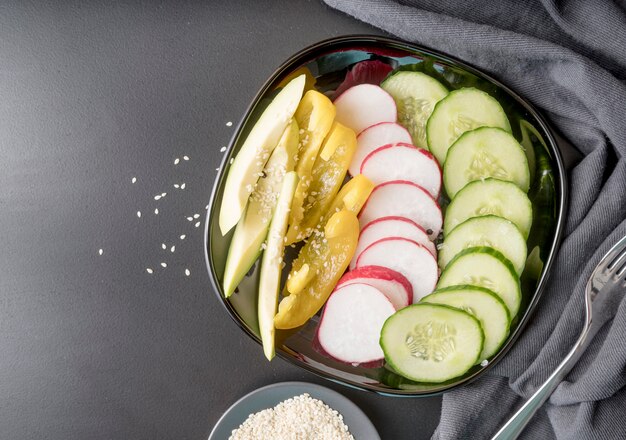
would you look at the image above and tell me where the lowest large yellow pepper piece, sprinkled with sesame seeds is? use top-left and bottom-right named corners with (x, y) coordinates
top-left (274, 210), bottom-right (359, 329)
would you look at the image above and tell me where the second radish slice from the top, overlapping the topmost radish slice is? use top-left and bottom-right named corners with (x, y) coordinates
top-left (348, 122), bottom-right (411, 176)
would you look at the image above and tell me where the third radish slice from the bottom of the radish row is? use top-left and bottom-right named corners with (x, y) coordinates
top-left (356, 237), bottom-right (439, 304)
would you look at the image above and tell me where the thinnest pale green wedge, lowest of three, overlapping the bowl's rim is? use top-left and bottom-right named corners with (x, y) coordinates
top-left (258, 171), bottom-right (298, 361)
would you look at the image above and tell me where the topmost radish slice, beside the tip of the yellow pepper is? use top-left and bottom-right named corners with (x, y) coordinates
top-left (334, 84), bottom-right (397, 134)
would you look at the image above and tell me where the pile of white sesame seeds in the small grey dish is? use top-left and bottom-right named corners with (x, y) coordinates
top-left (229, 393), bottom-right (354, 440)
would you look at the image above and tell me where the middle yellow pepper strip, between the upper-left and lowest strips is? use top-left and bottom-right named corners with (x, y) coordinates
top-left (287, 122), bottom-right (356, 245)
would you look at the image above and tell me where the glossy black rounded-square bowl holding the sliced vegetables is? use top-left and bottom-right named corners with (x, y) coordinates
top-left (205, 36), bottom-right (567, 396)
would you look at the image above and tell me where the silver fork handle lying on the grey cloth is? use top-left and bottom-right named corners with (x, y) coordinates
top-left (491, 323), bottom-right (590, 440)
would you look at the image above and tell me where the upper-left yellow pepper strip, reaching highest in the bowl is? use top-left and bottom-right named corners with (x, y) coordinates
top-left (289, 90), bottom-right (336, 237)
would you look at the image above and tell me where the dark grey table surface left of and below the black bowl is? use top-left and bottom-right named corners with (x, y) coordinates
top-left (0, 0), bottom-right (440, 440)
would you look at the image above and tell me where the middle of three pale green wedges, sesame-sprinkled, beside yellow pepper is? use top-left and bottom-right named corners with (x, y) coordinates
top-left (224, 120), bottom-right (299, 298)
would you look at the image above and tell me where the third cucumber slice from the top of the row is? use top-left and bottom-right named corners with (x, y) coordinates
top-left (443, 127), bottom-right (530, 197)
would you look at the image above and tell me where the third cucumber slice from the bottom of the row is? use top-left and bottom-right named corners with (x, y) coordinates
top-left (437, 247), bottom-right (522, 319)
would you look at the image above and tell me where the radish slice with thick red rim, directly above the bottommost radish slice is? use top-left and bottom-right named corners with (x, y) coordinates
top-left (337, 266), bottom-right (413, 310)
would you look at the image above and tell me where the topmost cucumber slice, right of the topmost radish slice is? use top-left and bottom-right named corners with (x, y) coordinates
top-left (380, 71), bottom-right (448, 148)
